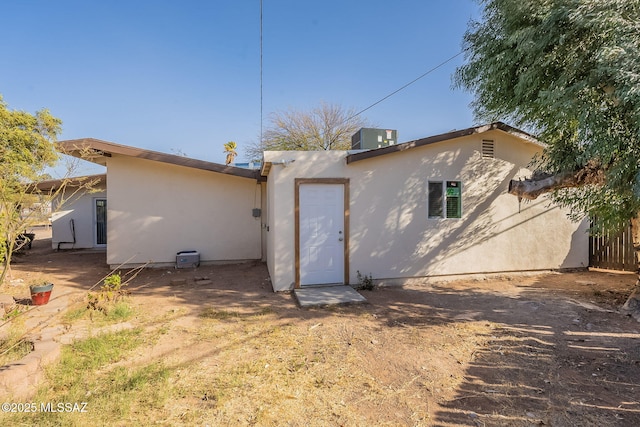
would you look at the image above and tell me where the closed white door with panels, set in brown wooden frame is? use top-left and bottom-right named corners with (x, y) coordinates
top-left (299, 184), bottom-right (345, 286)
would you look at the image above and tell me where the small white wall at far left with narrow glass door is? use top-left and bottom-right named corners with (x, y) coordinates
top-left (51, 186), bottom-right (107, 249)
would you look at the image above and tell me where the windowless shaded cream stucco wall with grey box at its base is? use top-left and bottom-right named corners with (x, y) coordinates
top-left (107, 155), bottom-right (262, 266)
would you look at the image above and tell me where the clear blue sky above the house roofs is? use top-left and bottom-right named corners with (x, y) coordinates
top-left (0, 0), bottom-right (480, 174)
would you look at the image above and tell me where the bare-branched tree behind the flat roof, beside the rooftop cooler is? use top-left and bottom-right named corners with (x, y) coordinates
top-left (247, 103), bottom-right (369, 159)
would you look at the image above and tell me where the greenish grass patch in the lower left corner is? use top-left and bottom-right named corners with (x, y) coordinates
top-left (6, 329), bottom-right (169, 426)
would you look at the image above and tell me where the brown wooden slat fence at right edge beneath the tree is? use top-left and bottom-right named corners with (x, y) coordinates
top-left (589, 224), bottom-right (637, 271)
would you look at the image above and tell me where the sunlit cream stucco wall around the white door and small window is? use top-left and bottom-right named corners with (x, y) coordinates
top-left (265, 130), bottom-right (588, 291)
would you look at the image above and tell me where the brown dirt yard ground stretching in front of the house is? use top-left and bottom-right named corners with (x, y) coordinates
top-left (3, 230), bottom-right (640, 426)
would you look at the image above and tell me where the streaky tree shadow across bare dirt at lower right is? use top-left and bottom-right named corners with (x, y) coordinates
top-left (367, 280), bottom-right (640, 426)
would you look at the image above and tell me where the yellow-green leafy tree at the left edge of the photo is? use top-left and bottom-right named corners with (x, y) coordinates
top-left (0, 97), bottom-right (61, 284)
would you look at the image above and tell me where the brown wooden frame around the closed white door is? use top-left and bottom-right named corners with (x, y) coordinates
top-left (294, 178), bottom-right (349, 289)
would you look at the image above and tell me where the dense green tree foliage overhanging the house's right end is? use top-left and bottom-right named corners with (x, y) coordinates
top-left (455, 0), bottom-right (640, 231)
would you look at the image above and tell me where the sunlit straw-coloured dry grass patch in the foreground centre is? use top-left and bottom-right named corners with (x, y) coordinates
top-left (152, 309), bottom-right (490, 425)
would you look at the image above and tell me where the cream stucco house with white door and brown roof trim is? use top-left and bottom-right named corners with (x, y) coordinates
top-left (61, 122), bottom-right (588, 291)
